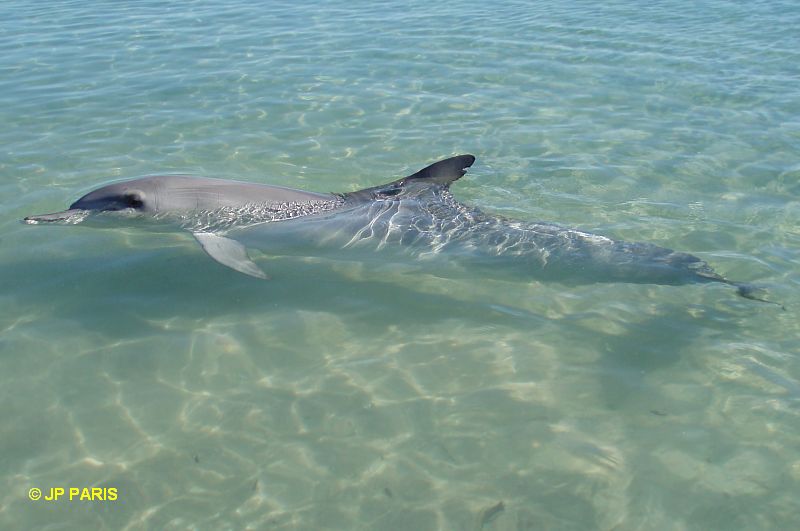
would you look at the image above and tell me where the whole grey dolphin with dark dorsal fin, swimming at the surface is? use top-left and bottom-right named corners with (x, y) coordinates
top-left (24, 155), bottom-right (769, 302)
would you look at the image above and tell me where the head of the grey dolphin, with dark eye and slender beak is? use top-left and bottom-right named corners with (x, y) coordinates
top-left (23, 178), bottom-right (158, 224)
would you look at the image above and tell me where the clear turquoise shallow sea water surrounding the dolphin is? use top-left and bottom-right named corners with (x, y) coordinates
top-left (0, 0), bottom-right (800, 530)
